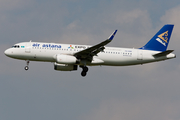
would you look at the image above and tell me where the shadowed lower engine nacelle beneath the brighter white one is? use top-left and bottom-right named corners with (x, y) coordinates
top-left (54, 63), bottom-right (77, 71)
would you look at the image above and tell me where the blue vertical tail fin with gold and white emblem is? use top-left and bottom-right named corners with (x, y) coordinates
top-left (140, 25), bottom-right (174, 51)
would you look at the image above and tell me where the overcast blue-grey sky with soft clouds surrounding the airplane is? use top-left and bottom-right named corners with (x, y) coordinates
top-left (0, 0), bottom-right (180, 120)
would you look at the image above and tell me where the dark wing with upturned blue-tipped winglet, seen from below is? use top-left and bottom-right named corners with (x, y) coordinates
top-left (74, 30), bottom-right (117, 61)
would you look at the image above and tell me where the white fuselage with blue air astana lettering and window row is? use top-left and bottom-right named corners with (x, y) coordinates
top-left (5, 42), bottom-right (175, 66)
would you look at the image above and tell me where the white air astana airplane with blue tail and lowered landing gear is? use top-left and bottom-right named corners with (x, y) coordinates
top-left (4, 24), bottom-right (176, 77)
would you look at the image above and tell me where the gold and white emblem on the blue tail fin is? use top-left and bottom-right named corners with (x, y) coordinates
top-left (156, 31), bottom-right (168, 46)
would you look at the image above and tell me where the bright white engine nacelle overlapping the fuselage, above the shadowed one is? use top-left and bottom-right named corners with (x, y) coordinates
top-left (55, 54), bottom-right (77, 64)
